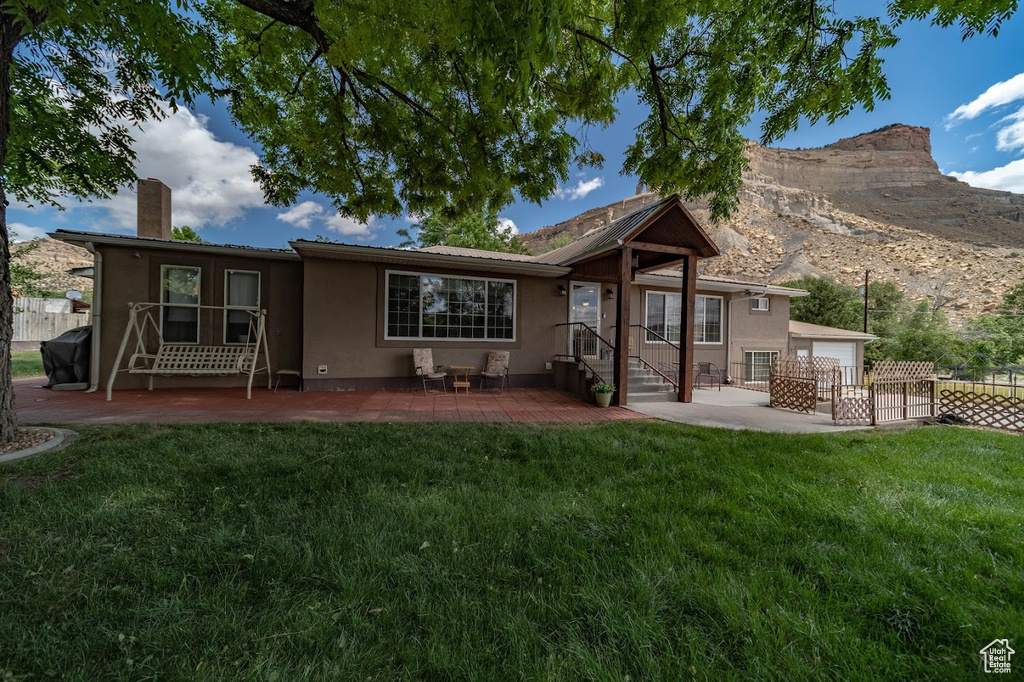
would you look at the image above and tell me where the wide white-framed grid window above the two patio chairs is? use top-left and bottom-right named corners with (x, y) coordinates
top-left (385, 272), bottom-right (515, 341)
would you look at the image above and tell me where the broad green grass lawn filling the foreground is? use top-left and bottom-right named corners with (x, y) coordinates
top-left (0, 422), bottom-right (1024, 681)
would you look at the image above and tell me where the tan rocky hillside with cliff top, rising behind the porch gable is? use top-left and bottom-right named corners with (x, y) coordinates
top-left (523, 125), bottom-right (1024, 319)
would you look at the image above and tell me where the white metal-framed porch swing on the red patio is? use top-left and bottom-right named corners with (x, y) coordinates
top-left (106, 303), bottom-right (271, 400)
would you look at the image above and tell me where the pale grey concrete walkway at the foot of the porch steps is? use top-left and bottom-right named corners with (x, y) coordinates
top-left (629, 386), bottom-right (871, 433)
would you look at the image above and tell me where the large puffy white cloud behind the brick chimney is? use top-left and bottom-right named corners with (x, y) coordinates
top-left (95, 108), bottom-right (264, 230)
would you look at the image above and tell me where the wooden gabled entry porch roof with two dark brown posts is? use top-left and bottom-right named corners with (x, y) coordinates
top-left (571, 196), bottom-right (719, 404)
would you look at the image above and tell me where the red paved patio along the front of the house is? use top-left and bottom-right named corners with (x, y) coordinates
top-left (14, 378), bottom-right (647, 424)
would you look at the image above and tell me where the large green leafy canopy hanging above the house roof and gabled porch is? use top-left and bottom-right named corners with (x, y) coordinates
top-left (214, 0), bottom-right (1017, 219)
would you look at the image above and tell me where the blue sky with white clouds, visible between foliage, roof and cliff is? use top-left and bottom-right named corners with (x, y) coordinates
top-left (8, 3), bottom-right (1024, 247)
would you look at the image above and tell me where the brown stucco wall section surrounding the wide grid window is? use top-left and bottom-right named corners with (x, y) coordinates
top-left (302, 257), bottom-right (568, 390)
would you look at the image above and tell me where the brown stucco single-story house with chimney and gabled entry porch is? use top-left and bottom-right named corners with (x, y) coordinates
top-left (51, 180), bottom-right (864, 403)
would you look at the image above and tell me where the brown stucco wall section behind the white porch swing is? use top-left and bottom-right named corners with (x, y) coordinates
top-left (97, 246), bottom-right (302, 391)
